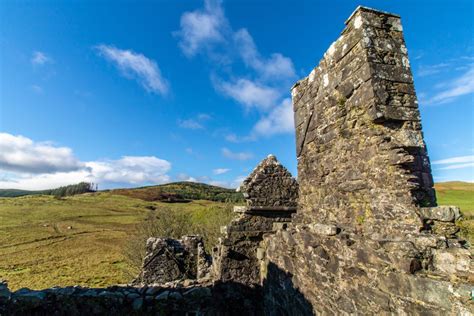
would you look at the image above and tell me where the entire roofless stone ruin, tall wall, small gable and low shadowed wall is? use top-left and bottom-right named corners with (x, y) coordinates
top-left (0, 7), bottom-right (474, 315)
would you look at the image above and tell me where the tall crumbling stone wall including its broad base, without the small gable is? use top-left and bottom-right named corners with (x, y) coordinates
top-left (262, 7), bottom-right (474, 315)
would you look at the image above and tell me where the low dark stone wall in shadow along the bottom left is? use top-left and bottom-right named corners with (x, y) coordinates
top-left (0, 282), bottom-right (262, 316)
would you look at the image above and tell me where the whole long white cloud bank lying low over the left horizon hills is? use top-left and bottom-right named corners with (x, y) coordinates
top-left (0, 133), bottom-right (171, 190)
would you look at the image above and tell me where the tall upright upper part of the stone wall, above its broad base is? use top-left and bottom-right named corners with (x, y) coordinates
top-left (292, 9), bottom-right (436, 234)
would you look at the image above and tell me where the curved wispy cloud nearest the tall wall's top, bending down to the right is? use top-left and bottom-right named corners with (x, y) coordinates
top-left (234, 28), bottom-right (295, 80)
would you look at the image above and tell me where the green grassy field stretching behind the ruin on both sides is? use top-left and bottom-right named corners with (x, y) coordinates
top-left (0, 182), bottom-right (474, 289)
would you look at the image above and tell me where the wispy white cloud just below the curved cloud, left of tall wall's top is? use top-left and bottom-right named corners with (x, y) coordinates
top-left (214, 79), bottom-right (280, 110)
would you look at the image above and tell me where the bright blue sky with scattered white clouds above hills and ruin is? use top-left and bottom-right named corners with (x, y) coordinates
top-left (0, 0), bottom-right (474, 189)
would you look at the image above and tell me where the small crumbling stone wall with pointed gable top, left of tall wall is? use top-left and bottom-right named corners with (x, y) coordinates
top-left (212, 155), bottom-right (298, 286)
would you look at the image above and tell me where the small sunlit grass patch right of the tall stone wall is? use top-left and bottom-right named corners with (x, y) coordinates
top-left (435, 182), bottom-right (474, 246)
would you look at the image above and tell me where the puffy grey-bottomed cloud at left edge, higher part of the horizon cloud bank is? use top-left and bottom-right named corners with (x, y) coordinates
top-left (0, 133), bottom-right (84, 173)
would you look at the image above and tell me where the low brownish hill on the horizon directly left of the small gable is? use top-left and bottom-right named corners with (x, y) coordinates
top-left (109, 182), bottom-right (244, 203)
